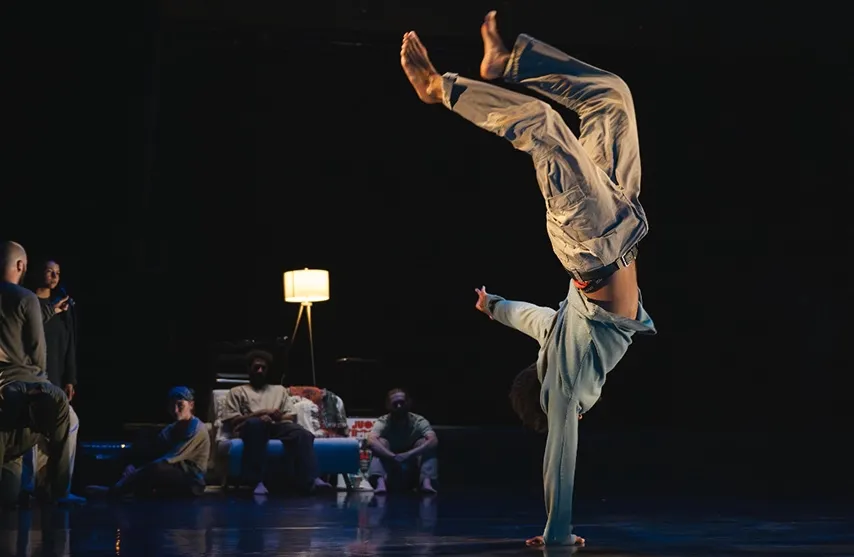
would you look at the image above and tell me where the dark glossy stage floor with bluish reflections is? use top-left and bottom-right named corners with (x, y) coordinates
top-left (0, 489), bottom-right (854, 557)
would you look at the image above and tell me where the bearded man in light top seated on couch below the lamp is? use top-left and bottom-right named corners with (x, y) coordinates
top-left (222, 351), bottom-right (331, 495)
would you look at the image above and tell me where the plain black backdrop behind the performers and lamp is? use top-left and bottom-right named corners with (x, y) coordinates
top-left (0, 1), bottom-right (854, 444)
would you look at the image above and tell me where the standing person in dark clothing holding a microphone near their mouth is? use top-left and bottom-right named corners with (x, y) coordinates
top-left (21, 259), bottom-right (80, 504)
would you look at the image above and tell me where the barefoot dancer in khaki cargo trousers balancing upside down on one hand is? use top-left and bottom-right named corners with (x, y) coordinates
top-left (400, 11), bottom-right (655, 545)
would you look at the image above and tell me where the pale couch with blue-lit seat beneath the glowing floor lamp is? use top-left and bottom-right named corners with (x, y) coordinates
top-left (209, 389), bottom-right (361, 489)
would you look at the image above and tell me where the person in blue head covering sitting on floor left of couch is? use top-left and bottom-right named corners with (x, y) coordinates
top-left (88, 387), bottom-right (211, 496)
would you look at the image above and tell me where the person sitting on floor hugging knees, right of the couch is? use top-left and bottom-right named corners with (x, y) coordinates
top-left (368, 389), bottom-right (439, 494)
